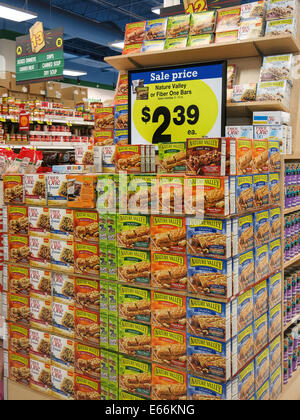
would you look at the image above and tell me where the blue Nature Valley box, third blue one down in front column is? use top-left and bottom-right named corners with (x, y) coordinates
top-left (186, 298), bottom-right (234, 342)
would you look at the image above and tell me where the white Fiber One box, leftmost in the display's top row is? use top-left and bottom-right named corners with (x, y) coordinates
top-left (24, 174), bottom-right (47, 206)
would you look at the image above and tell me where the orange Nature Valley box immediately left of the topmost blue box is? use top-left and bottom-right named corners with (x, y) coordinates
top-left (151, 216), bottom-right (187, 254)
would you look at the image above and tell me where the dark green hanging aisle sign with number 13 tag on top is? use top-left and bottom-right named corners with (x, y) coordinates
top-left (16, 22), bottom-right (64, 85)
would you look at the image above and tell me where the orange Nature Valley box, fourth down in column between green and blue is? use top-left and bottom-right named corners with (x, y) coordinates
top-left (151, 290), bottom-right (187, 332)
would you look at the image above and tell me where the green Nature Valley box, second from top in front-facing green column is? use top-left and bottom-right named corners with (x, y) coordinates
top-left (117, 214), bottom-right (150, 251)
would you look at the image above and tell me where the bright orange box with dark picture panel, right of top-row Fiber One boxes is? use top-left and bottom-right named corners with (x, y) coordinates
top-left (67, 174), bottom-right (97, 209)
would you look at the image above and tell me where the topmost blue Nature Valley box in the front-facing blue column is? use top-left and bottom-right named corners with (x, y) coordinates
top-left (187, 218), bottom-right (231, 259)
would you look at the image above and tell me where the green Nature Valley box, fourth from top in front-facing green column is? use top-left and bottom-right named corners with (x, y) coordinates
top-left (118, 284), bottom-right (151, 323)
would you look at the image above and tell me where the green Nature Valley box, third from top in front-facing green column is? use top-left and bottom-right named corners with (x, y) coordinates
top-left (118, 248), bottom-right (151, 286)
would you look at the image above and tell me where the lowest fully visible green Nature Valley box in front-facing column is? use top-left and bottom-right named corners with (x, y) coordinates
top-left (119, 354), bottom-right (152, 398)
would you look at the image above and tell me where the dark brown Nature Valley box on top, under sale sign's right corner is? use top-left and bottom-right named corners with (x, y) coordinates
top-left (186, 138), bottom-right (226, 176)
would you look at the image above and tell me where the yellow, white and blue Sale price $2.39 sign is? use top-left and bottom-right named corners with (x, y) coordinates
top-left (129, 61), bottom-right (227, 144)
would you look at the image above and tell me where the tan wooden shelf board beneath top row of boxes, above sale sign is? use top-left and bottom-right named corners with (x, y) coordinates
top-left (105, 35), bottom-right (300, 71)
